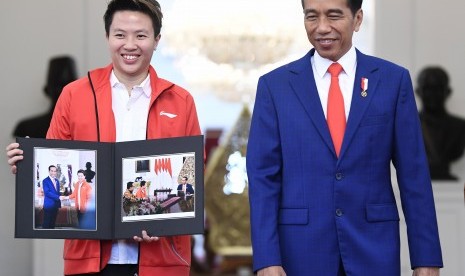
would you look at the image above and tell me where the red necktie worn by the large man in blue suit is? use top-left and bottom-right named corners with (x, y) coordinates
top-left (327, 63), bottom-right (346, 157)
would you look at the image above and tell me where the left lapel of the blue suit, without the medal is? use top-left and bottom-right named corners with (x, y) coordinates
top-left (289, 49), bottom-right (336, 154)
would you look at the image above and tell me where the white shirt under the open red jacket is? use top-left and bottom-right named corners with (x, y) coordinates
top-left (108, 72), bottom-right (152, 264)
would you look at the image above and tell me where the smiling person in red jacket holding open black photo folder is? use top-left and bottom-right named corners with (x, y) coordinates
top-left (7, 0), bottom-right (200, 276)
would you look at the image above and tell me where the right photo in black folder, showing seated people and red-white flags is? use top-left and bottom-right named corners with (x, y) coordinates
top-left (121, 152), bottom-right (195, 222)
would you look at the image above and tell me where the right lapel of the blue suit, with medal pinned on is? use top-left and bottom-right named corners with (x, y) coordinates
top-left (339, 50), bottom-right (379, 160)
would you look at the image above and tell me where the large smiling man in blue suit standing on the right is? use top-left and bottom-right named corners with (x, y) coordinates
top-left (247, 0), bottom-right (443, 276)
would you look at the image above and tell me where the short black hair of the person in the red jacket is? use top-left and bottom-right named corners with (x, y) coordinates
top-left (103, 0), bottom-right (163, 37)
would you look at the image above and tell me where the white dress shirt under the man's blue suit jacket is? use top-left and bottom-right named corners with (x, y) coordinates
top-left (311, 46), bottom-right (361, 120)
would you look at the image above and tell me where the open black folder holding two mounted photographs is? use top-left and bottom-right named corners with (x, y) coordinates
top-left (15, 136), bottom-right (204, 239)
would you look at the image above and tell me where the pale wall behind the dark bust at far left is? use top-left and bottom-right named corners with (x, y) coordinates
top-left (0, 0), bottom-right (109, 276)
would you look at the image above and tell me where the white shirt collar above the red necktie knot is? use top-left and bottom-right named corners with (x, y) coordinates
top-left (313, 45), bottom-right (357, 79)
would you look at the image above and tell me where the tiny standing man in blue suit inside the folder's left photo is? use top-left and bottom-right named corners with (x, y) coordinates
top-left (42, 165), bottom-right (61, 229)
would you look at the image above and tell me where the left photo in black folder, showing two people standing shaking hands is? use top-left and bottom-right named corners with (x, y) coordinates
top-left (33, 147), bottom-right (98, 231)
